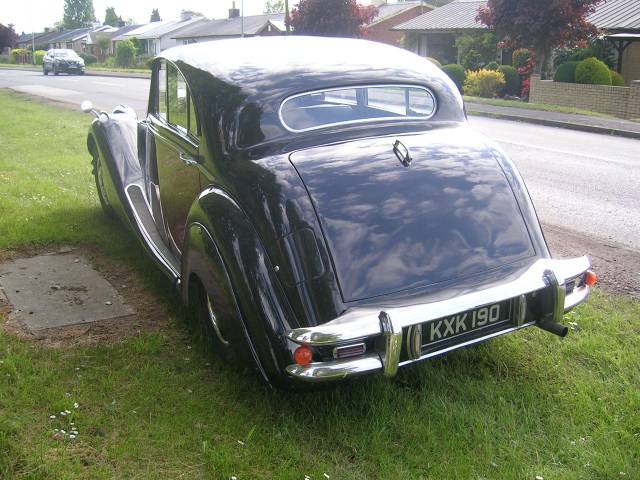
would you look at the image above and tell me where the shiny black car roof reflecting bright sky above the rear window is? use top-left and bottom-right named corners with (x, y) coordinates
top-left (160, 35), bottom-right (450, 95)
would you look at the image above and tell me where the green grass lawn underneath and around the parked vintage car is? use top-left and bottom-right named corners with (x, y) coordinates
top-left (0, 92), bottom-right (640, 480)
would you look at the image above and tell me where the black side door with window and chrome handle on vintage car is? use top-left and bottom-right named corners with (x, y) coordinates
top-left (149, 60), bottom-right (200, 255)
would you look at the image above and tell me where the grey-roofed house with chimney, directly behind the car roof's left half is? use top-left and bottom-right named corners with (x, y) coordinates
top-left (174, 2), bottom-right (286, 45)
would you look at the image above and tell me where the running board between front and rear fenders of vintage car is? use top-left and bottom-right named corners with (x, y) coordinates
top-left (125, 184), bottom-right (180, 285)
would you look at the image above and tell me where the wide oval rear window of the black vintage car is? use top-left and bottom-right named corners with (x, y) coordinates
top-left (280, 85), bottom-right (436, 132)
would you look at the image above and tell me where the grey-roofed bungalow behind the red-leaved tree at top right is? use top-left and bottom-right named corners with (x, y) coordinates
top-left (394, 0), bottom-right (640, 83)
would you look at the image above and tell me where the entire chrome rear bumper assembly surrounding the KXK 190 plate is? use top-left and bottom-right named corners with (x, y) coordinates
top-left (286, 257), bottom-right (593, 382)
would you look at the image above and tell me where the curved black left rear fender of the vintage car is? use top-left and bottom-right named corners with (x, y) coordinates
top-left (182, 187), bottom-right (292, 382)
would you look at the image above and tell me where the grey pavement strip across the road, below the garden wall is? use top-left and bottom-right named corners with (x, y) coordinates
top-left (465, 102), bottom-right (640, 138)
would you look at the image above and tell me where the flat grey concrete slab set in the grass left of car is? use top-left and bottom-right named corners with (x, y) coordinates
top-left (0, 253), bottom-right (135, 331)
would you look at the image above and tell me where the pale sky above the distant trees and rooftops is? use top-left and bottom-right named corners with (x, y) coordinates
top-left (0, 0), bottom-right (284, 34)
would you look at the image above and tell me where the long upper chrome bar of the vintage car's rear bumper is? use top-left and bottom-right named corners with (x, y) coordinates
top-left (286, 257), bottom-right (590, 346)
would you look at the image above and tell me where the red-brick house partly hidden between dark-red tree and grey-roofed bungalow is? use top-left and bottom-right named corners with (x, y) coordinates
top-left (366, 0), bottom-right (435, 46)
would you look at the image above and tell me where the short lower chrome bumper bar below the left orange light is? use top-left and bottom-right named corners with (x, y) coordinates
top-left (286, 353), bottom-right (382, 382)
